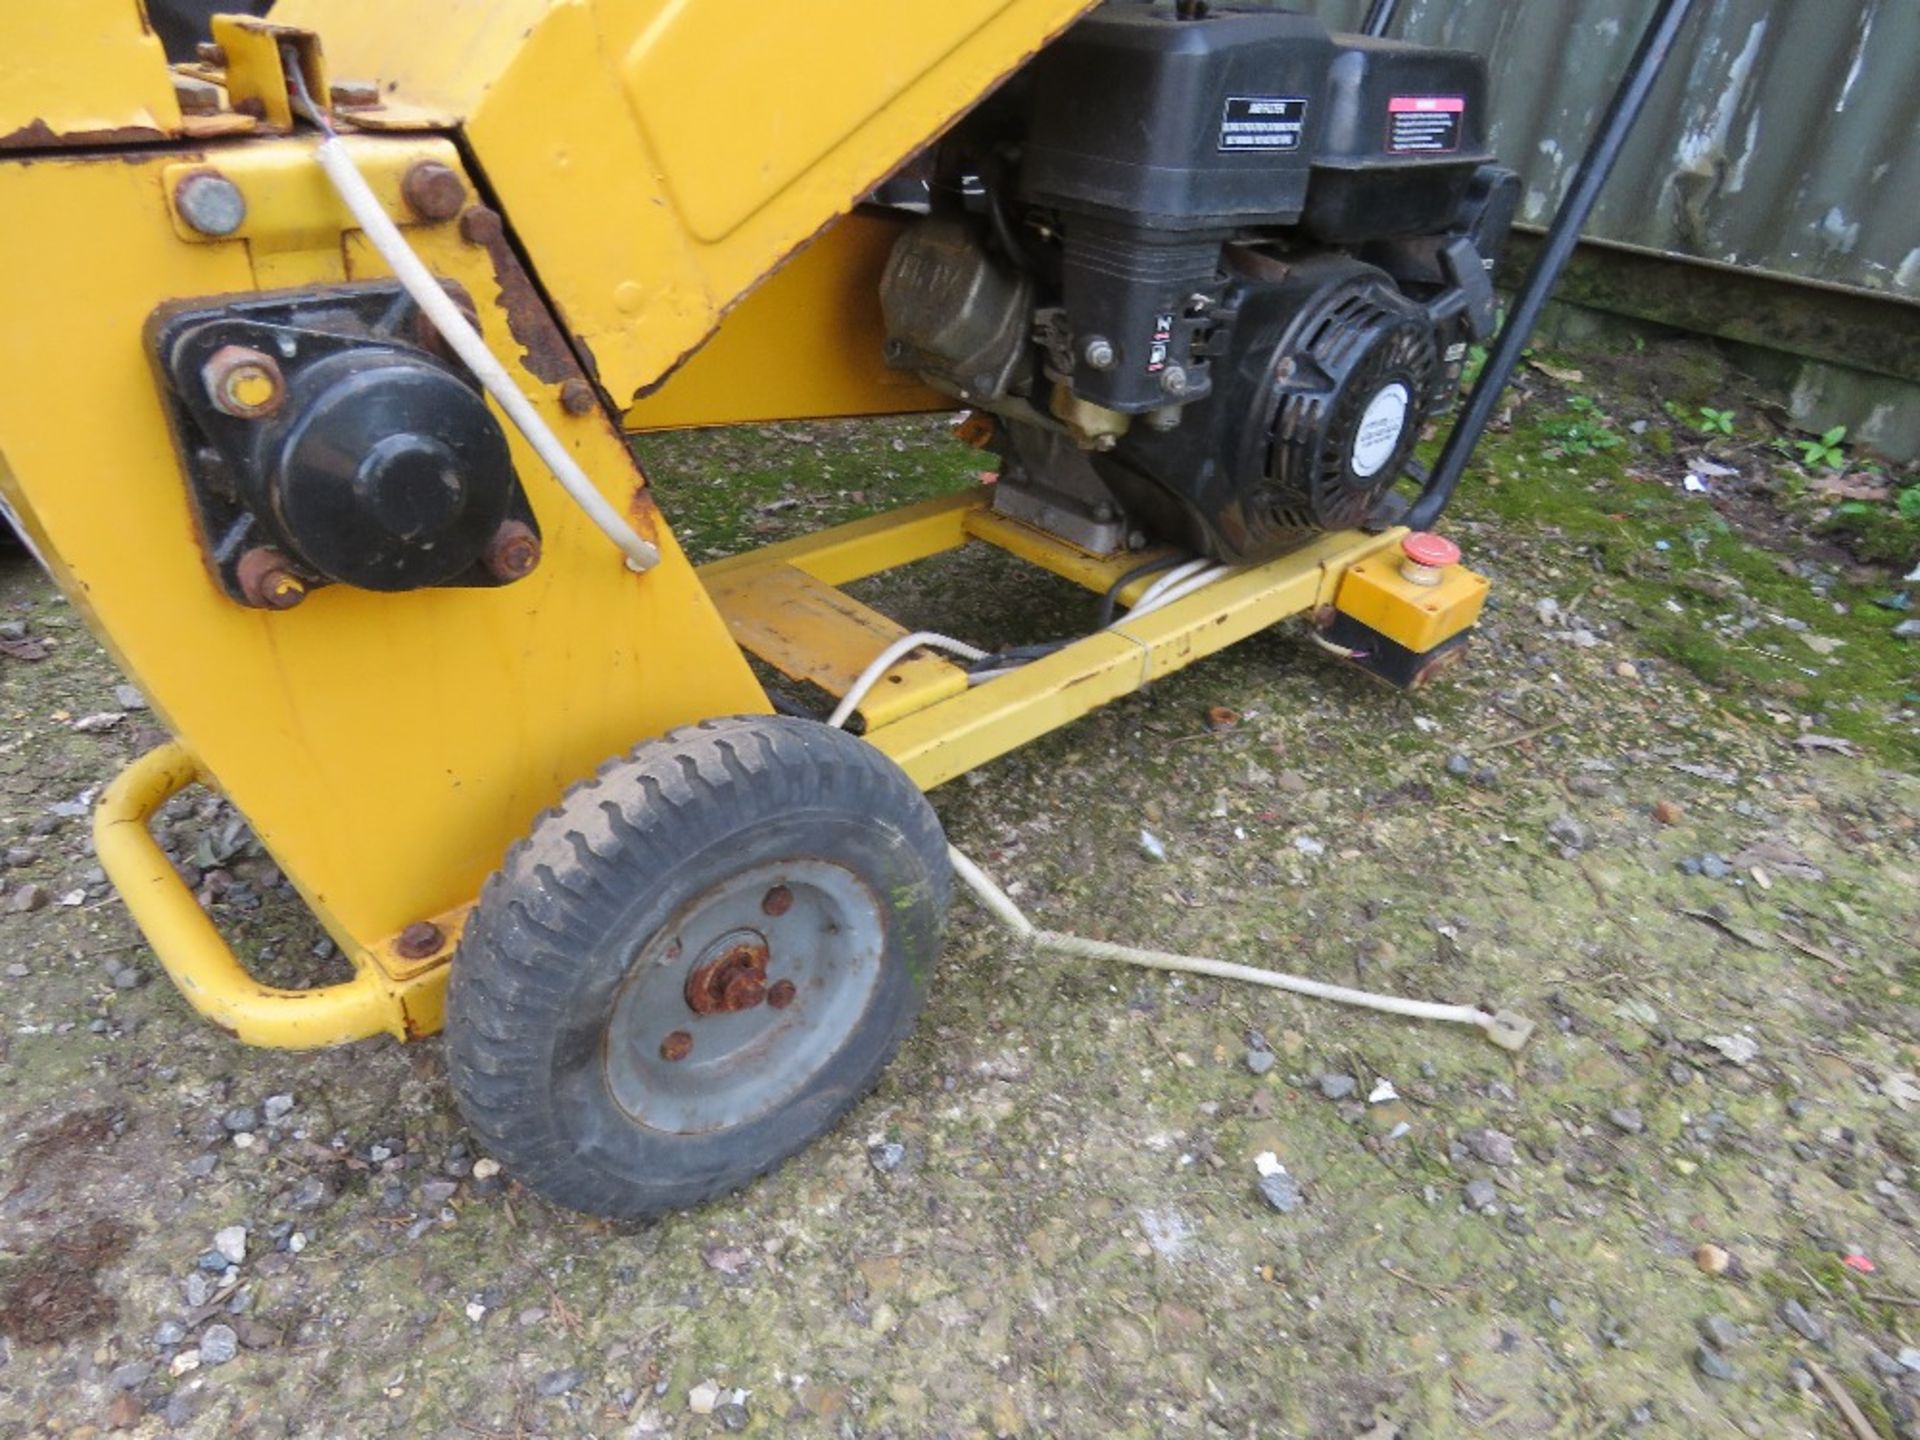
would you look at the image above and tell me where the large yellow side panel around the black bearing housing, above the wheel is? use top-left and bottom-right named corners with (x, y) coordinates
top-left (0, 138), bottom-right (768, 963)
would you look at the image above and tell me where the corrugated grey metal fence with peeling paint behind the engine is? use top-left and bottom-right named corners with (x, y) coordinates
top-left (1286, 0), bottom-right (1920, 300)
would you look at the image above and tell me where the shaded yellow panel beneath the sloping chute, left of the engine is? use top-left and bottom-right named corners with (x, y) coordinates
top-left (626, 213), bottom-right (952, 430)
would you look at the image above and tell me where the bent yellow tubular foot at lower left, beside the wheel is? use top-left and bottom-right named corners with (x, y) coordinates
top-left (94, 743), bottom-right (461, 1048)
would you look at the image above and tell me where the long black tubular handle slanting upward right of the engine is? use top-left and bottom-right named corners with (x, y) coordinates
top-left (1402, 0), bottom-right (1693, 530)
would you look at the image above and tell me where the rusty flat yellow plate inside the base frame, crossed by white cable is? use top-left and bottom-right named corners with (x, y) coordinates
top-left (701, 564), bottom-right (966, 728)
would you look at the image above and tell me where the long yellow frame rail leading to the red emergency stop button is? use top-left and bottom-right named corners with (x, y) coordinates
top-left (868, 532), bottom-right (1398, 789)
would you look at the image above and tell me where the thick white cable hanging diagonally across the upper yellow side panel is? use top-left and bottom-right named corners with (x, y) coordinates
top-left (315, 136), bottom-right (660, 570)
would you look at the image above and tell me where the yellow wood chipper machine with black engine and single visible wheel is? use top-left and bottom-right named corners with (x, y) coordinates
top-left (0, 0), bottom-right (1681, 1215)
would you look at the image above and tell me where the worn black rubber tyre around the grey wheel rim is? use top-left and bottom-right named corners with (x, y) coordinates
top-left (445, 716), bottom-right (952, 1219)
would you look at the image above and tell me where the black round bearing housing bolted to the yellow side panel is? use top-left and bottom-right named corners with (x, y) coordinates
top-left (150, 282), bottom-right (540, 609)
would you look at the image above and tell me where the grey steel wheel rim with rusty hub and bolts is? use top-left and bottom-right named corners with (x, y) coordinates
top-left (601, 860), bottom-right (887, 1135)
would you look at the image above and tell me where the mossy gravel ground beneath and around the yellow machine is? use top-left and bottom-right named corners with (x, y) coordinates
top-left (0, 341), bottom-right (1920, 1440)
